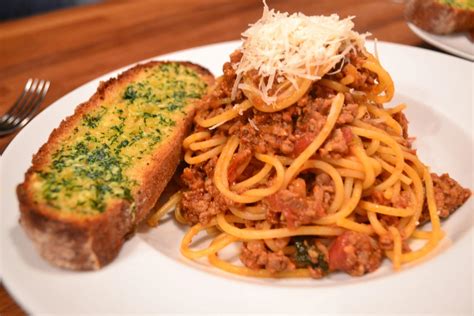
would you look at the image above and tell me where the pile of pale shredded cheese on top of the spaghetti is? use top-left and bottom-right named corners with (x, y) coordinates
top-left (232, 4), bottom-right (369, 104)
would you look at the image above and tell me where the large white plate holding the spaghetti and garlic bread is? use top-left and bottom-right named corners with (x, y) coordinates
top-left (0, 42), bottom-right (474, 314)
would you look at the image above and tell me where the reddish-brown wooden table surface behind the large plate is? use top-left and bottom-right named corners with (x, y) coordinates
top-left (0, 0), bottom-right (440, 315)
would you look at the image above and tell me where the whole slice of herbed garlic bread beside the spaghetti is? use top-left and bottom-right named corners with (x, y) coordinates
top-left (17, 62), bottom-right (213, 270)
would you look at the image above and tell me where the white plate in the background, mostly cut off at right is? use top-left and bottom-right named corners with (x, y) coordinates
top-left (408, 23), bottom-right (474, 61)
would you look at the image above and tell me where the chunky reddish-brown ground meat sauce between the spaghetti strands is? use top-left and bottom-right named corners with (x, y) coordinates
top-left (182, 52), bottom-right (470, 278)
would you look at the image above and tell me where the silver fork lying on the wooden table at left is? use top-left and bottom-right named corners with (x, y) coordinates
top-left (0, 78), bottom-right (50, 136)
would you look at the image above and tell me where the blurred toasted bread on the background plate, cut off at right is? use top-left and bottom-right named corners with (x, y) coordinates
top-left (405, 0), bottom-right (474, 34)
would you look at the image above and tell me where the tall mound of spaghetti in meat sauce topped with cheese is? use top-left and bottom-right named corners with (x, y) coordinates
top-left (150, 9), bottom-right (470, 278)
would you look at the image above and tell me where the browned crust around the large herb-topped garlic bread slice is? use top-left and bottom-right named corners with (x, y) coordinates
top-left (17, 61), bottom-right (214, 270)
